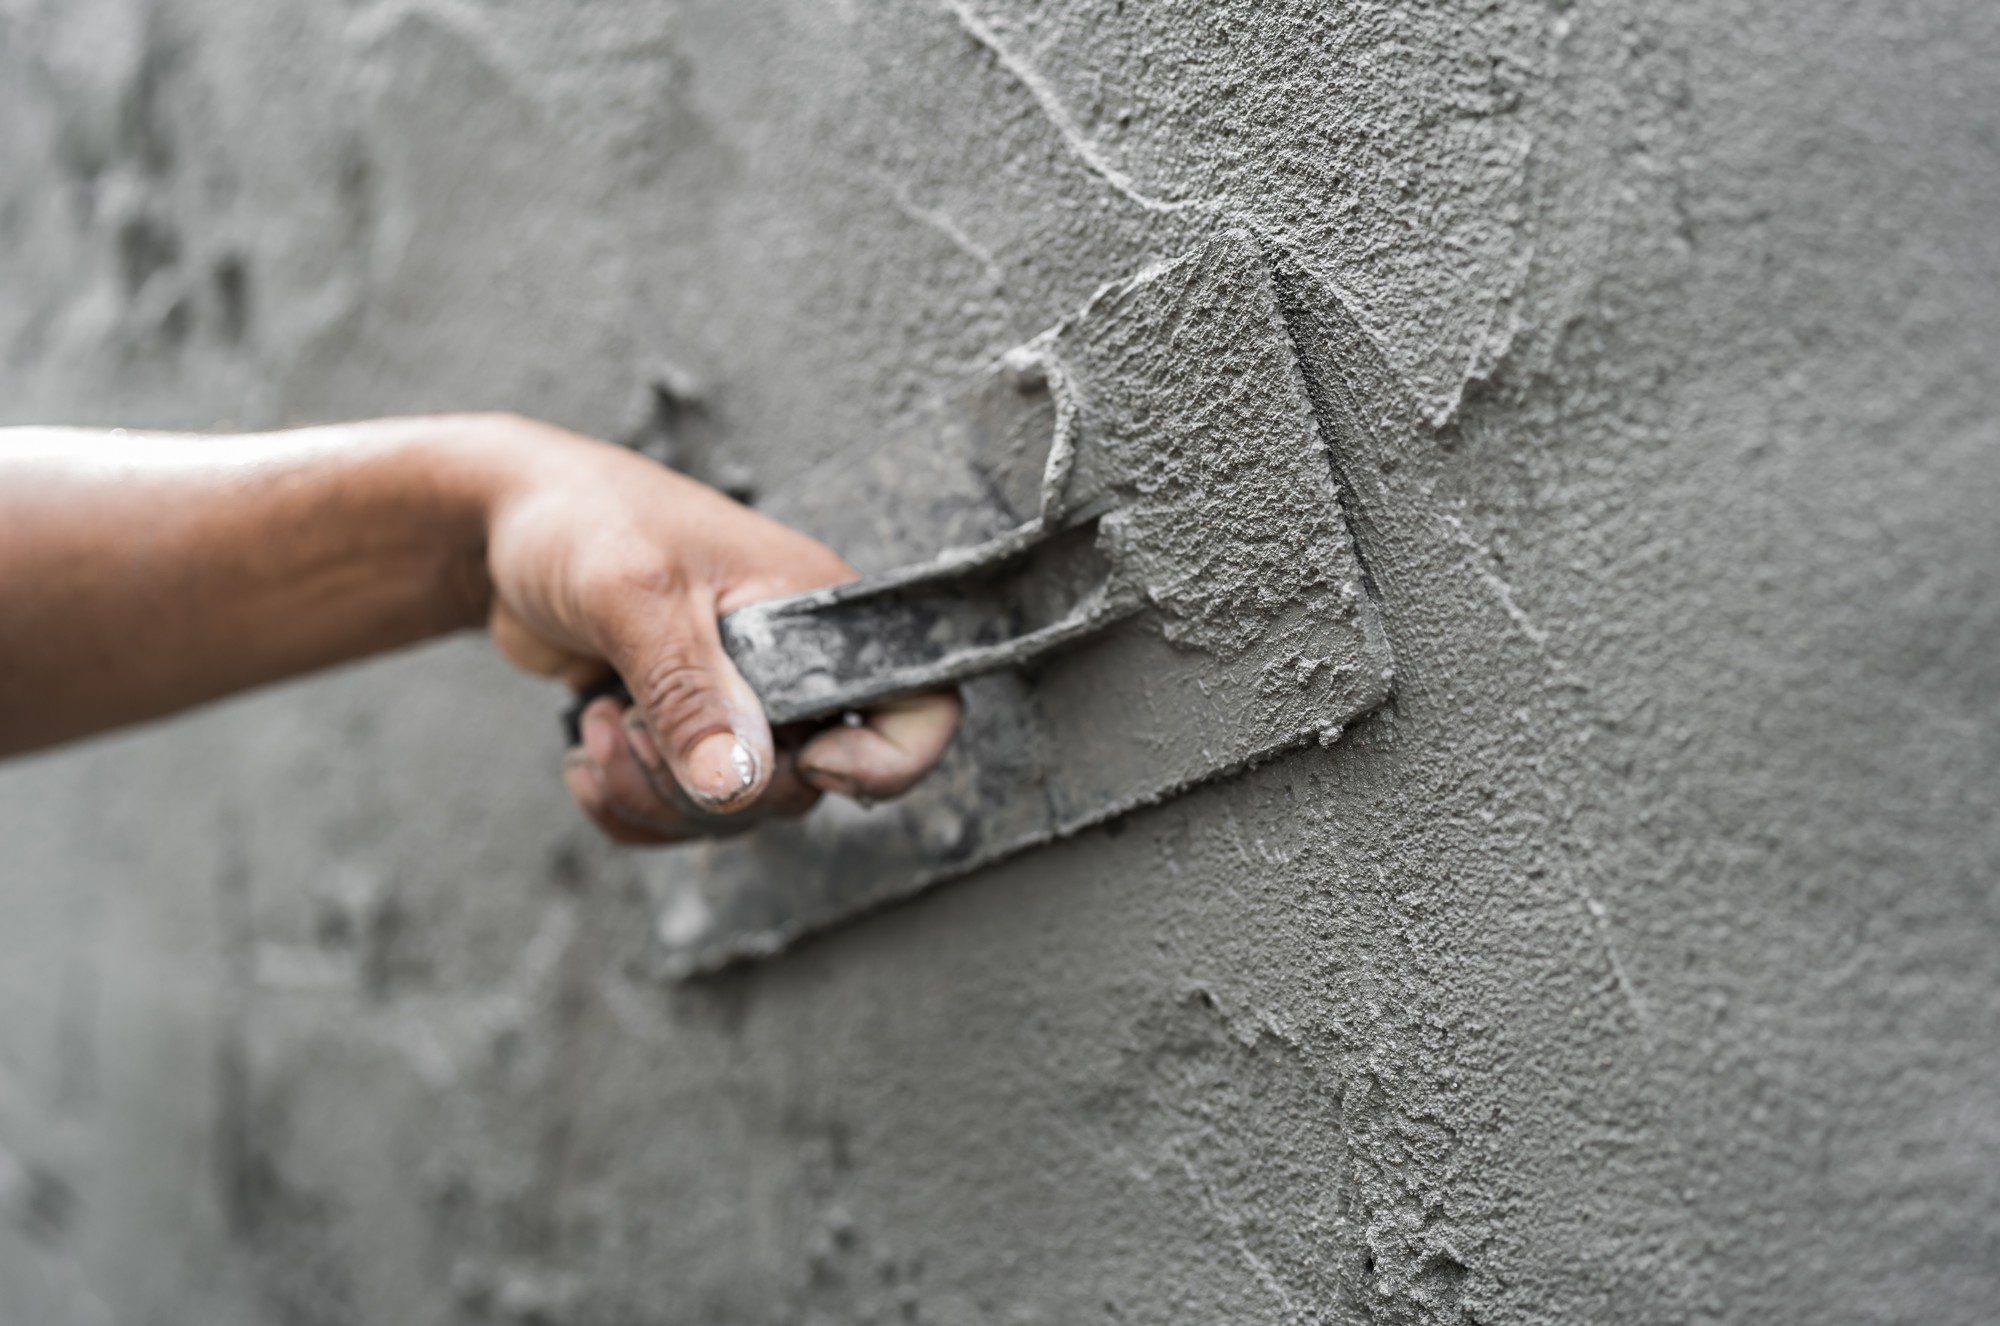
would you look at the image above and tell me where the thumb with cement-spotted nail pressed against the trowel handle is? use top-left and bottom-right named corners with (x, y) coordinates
top-left (608, 600), bottom-right (774, 814)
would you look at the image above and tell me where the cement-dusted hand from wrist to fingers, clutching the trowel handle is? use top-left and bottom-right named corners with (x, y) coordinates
top-left (486, 418), bottom-right (960, 844)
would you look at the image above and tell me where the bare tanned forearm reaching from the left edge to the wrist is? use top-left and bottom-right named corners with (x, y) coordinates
top-left (0, 418), bottom-right (504, 754)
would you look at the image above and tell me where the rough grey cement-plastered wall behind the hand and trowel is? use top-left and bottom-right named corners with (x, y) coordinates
top-left (0, 0), bottom-right (2000, 1326)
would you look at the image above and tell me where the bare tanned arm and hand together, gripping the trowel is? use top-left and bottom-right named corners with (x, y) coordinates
top-left (0, 414), bottom-right (960, 844)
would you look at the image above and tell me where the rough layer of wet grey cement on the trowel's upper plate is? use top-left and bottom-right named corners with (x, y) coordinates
top-left (1052, 232), bottom-right (1356, 658)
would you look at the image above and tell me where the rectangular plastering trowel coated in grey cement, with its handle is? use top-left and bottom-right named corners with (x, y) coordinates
top-left (580, 232), bottom-right (1390, 976)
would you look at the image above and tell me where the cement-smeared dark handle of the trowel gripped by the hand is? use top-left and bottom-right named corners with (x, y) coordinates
top-left (564, 522), bottom-right (1138, 744)
